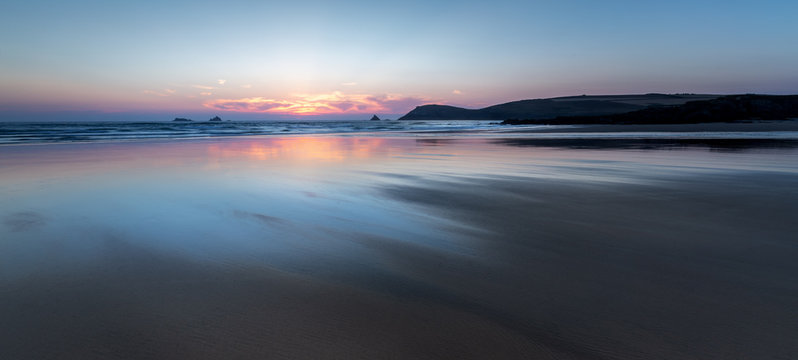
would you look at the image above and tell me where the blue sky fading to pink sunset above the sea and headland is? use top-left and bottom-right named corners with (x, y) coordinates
top-left (0, 0), bottom-right (798, 120)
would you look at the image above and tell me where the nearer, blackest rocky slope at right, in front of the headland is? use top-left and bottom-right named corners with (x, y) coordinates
top-left (503, 94), bottom-right (798, 124)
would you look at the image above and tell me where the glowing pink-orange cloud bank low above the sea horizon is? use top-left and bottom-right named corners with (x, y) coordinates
top-left (204, 91), bottom-right (425, 115)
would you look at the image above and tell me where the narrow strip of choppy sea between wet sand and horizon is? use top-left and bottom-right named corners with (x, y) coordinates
top-left (0, 120), bottom-right (798, 146)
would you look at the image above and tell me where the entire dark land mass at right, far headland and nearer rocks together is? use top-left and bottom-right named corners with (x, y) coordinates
top-left (399, 94), bottom-right (798, 125)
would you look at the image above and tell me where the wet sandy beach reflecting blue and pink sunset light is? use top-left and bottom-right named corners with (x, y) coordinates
top-left (0, 136), bottom-right (798, 359)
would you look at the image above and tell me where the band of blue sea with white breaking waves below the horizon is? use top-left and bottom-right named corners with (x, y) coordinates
top-left (0, 120), bottom-right (798, 145)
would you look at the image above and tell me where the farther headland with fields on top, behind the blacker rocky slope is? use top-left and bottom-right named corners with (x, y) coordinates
top-left (399, 94), bottom-right (717, 120)
